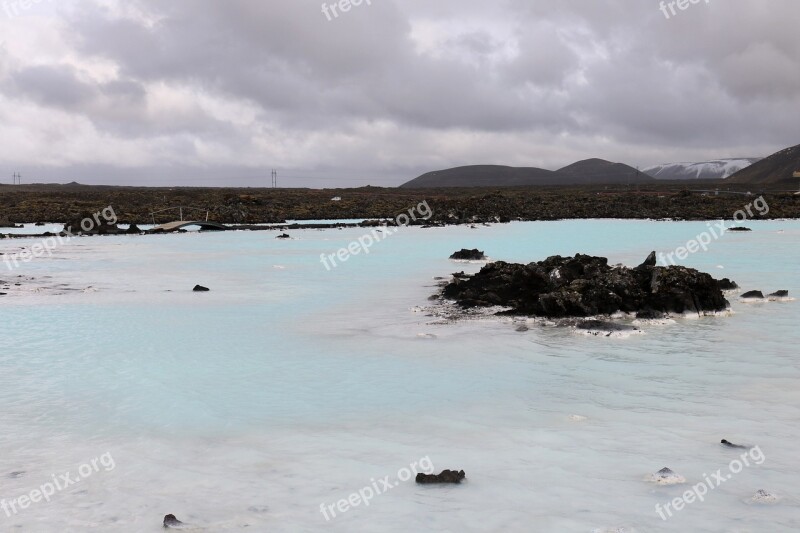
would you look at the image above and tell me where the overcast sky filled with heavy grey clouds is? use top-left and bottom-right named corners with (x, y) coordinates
top-left (0, 0), bottom-right (800, 188)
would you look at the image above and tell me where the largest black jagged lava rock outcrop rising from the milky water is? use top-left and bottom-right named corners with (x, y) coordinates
top-left (442, 254), bottom-right (729, 318)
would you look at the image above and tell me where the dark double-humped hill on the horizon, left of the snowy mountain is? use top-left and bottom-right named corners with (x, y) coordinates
top-left (401, 159), bottom-right (653, 189)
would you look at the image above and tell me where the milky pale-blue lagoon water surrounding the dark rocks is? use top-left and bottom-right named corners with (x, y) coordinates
top-left (0, 220), bottom-right (800, 533)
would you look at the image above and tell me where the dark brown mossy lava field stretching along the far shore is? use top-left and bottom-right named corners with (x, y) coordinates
top-left (0, 182), bottom-right (800, 226)
